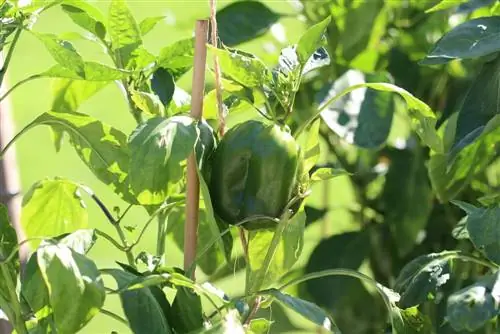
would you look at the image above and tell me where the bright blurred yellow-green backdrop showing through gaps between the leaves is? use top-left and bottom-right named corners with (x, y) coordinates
top-left (7, 0), bottom-right (355, 334)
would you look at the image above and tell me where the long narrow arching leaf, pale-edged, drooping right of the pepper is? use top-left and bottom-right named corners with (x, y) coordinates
top-left (319, 83), bottom-right (444, 153)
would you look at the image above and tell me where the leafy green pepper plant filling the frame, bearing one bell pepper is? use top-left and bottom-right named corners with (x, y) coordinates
top-left (0, 0), bottom-right (500, 333)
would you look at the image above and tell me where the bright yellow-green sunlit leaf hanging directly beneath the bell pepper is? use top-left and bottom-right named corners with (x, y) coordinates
top-left (246, 207), bottom-right (306, 292)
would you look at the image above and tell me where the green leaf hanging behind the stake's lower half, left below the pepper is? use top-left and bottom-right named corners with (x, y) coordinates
top-left (167, 171), bottom-right (233, 275)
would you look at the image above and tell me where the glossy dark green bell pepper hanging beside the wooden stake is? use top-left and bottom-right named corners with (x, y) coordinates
top-left (209, 121), bottom-right (303, 230)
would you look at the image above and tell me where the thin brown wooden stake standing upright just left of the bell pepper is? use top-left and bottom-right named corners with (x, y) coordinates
top-left (184, 20), bottom-right (208, 279)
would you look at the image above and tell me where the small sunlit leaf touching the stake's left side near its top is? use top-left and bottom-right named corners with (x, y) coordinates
top-left (157, 38), bottom-right (194, 81)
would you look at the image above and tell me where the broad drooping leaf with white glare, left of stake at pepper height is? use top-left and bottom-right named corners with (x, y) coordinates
top-left (129, 116), bottom-right (198, 205)
